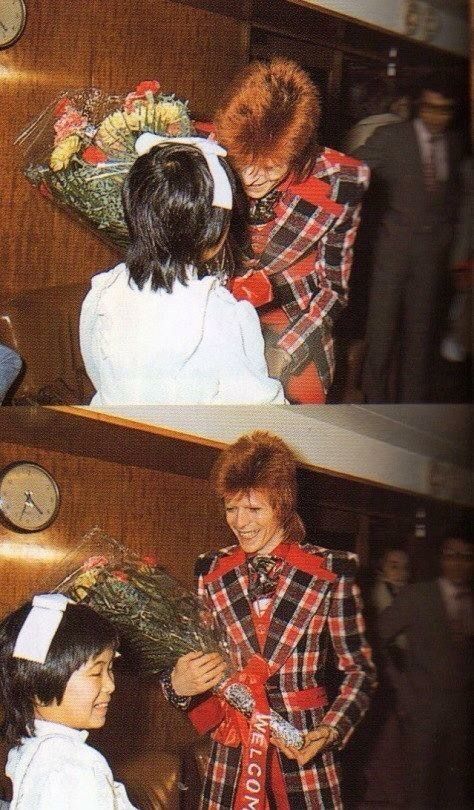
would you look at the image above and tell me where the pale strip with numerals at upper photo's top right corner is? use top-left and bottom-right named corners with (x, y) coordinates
top-left (290, 0), bottom-right (469, 56)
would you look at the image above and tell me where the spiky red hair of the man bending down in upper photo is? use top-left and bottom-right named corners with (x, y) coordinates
top-left (214, 57), bottom-right (321, 180)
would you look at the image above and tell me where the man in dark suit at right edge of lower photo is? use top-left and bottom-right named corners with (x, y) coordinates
top-left (379, 526), bottom-right (474, 810)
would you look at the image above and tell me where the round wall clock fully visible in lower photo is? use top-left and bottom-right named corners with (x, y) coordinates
top-left (0, 461), bottom-right (59, 532)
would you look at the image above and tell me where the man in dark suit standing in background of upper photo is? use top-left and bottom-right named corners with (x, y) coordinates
top-left (355, 75), bottom-right (462, 402)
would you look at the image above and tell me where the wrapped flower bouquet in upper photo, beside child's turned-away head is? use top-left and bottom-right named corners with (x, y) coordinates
top-left (15, 81), bottom-right (193, 248)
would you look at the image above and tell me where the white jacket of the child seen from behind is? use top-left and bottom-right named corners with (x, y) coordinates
top-left (80, 263), bottom-right (285, 406)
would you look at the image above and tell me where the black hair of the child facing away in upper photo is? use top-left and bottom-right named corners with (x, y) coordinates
top-left (122, 143), bottom-right (236, 292)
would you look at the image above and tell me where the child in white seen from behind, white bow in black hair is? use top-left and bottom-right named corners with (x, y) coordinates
top-left (80, 133), bottom-right (285, 406)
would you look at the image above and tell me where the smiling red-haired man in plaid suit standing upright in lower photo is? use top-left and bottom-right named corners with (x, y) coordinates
top-left (162, 430), bottom-right (376, 810)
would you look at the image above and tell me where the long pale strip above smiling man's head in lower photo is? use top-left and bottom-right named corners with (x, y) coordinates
top-left (78, 405), bottom-right (473, 505)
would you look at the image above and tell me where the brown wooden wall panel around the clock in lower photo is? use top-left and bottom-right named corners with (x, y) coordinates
top-left (0, 436), bottom-right (230, 605)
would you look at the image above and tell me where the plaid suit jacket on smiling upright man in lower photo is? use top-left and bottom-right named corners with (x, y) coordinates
top-left (196, 545), bottom-right (375, 810)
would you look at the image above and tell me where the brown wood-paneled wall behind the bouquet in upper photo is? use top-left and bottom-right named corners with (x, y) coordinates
top-left (0, 0), bottom-right (248, 298)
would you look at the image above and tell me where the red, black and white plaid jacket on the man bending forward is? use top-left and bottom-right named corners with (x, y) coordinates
top-left (251, 149), bottom-right (369, 391)
